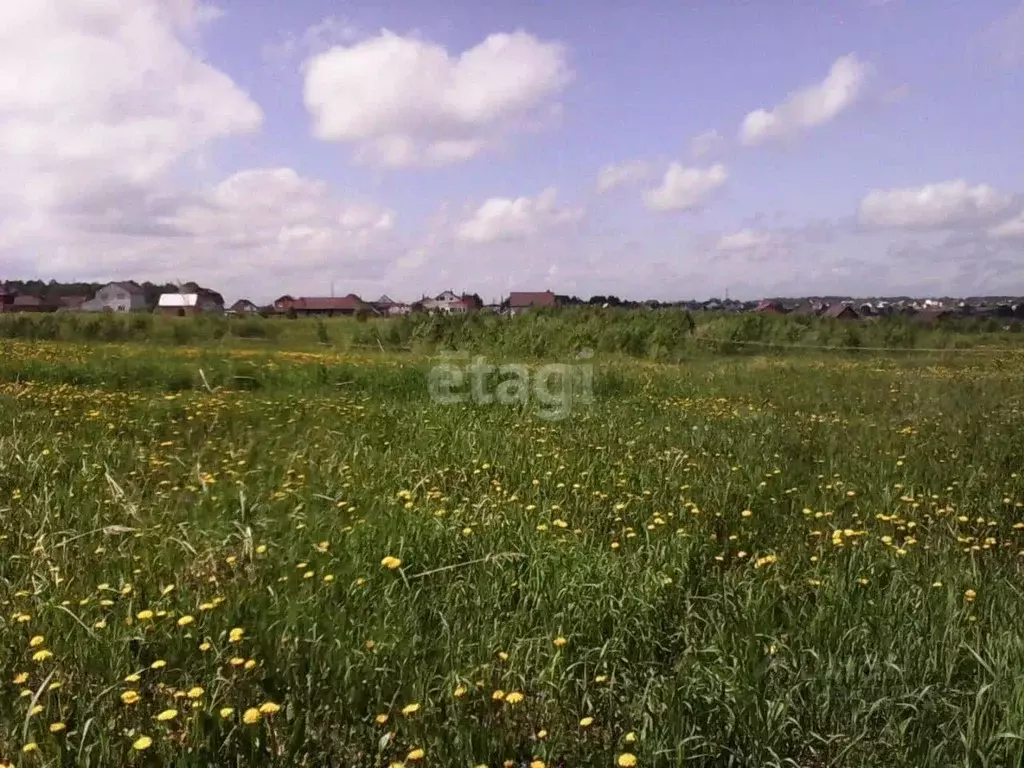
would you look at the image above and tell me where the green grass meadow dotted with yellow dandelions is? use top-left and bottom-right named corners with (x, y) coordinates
top-left (0, 341), bottom-right (1024, 768)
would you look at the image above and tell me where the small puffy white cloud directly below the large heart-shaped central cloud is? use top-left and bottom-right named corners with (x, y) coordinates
top-left (456, 187), bottom-right (584, 244)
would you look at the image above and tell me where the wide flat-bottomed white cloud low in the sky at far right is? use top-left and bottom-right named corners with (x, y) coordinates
top-left (858, 179), bottom-right (1013, 229)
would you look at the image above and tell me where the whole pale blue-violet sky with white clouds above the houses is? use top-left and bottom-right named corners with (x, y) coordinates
top-left (0, 0), bottom-right (1024, 301)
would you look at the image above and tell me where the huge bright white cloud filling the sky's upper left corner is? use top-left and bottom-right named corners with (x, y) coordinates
top-left (0, 0), bottom-right (263, 215)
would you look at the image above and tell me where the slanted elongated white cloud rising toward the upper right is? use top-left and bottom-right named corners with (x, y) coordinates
top-left (739, 53), bottom-right (870, 145)
